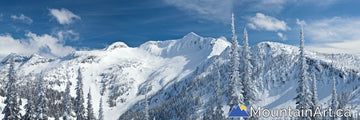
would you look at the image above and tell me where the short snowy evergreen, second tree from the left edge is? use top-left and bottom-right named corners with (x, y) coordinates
top-left (22, 82), bottom-right (36, 120)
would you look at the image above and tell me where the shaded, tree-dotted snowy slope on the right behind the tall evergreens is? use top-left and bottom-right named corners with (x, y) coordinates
top-left (121, 42), bottom-right (360, 119)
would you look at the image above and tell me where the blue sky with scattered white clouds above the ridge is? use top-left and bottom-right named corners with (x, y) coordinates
top-left (0, 0), bottom-right (360, 57)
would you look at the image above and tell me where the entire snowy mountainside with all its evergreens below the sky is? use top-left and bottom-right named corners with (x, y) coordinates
top-left (0, 13), bottom-right (360, 120)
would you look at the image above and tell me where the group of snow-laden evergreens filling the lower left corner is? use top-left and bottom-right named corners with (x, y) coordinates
top-left (2, 57), bottom-right (104, 120)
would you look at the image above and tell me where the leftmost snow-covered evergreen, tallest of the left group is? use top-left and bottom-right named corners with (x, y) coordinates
top-left (2, 57), bottom-right (21, 120)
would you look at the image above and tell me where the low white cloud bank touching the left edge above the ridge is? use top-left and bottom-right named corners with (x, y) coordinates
top-left (0, 32), bottom-right (75, 58)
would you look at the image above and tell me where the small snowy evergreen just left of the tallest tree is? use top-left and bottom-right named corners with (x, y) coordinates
top-left (213, 70), bottom-right (225, 120)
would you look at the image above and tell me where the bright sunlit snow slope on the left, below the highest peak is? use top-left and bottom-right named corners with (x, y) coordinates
top-left (0, 33), bottom-right (229, 120)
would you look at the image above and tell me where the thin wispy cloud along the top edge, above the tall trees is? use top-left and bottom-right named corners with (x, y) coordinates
top-left (163, 0), bottom-right (339, 23)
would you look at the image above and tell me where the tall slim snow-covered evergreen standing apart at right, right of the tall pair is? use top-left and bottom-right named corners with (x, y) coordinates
top-left (295, 25), bottom-right (312, 119)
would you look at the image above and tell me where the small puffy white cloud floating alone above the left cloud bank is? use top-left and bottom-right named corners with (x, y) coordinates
top-left (49, 8), bottom-right (81, 25)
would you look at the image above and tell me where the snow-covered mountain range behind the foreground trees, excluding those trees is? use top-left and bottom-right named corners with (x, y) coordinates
top-left (0, 33), bottom-right (360, 120)
